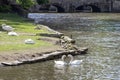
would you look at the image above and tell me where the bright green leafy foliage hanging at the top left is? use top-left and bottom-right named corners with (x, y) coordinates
top-left (16, 0), bottom-right (35, 9)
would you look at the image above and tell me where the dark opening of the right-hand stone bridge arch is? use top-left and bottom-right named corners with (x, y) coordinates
top-left (76, 5), bottom-right (101, 12)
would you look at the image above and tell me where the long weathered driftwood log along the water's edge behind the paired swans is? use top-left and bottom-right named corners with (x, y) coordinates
top-left (0, 48), bottom-right (88, 66)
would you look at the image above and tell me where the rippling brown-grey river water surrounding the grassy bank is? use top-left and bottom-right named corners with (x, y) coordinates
top-left (0, 14), bottom-right (120, 80)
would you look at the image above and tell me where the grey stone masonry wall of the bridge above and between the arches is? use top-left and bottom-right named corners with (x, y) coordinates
top-left (49, 0), bottom-right (120, 12)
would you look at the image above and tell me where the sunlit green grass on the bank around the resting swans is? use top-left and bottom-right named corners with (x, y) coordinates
top-left (0, 13), bottom-right (52, 52)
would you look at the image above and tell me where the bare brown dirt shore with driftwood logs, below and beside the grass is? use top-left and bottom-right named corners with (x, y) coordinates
top-left (0, 26), bottom-right (88, 66)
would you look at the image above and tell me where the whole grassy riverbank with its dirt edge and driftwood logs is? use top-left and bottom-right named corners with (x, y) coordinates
top-left (0, 14), bottom-right (87, 66)
